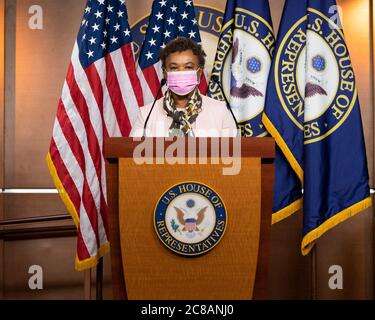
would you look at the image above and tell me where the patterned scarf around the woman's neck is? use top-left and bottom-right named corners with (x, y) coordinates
top-left (163, 88), bottom-right (202, 137)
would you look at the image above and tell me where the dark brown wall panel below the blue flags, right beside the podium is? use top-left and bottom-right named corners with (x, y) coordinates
top-left (269, 212), bottom-right (312, 299)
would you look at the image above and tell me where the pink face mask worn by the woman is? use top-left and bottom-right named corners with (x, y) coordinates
top-left (167, 70), bottom-right (199, 96)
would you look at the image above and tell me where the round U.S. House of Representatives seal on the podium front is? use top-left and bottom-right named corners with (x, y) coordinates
top-left (154, 182), bottom-right (227, 256)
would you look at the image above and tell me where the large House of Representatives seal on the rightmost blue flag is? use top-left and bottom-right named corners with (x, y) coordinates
top-left (275, 8), bottom-right (357, 144)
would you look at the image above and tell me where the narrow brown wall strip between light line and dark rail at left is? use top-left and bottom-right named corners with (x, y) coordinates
top-left (4, 194), bottom-right (68, 219)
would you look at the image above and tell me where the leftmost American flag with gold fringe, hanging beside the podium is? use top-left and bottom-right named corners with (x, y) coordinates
top-left (47, 0), bottom-right (143, 270)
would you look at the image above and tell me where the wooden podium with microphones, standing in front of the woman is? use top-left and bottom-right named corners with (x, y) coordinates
top-left (105, 138), bottom-right (275, 300)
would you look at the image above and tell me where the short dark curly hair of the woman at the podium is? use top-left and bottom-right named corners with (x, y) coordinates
top-left (160, 37), bottom-right (206, 69)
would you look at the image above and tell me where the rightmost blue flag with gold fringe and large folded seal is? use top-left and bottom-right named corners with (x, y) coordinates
top-left (263, 0), bottom-right (372, 255)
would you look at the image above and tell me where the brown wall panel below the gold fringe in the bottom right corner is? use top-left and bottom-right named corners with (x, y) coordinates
top-left (316, 198), bottom-right (374, 299)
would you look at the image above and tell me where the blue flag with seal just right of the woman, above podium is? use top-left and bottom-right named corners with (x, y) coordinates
top-left (207, 0), bottom-right (275, 137)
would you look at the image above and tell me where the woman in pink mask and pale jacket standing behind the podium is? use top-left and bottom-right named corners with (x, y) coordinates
top-left (130, 37), bottom-right (237, 137)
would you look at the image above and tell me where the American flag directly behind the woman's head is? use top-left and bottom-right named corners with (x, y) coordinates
top-left (137, 0), bottom-right (207, 104)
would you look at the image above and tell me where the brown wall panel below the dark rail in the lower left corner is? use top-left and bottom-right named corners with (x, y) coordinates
top-left (4, 238), bottom-right (83, 299)
